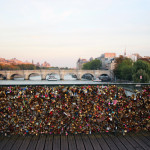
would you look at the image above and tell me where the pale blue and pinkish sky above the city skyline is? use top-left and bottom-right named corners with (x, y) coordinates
top-left (0, 0), bottom-right (150, 67)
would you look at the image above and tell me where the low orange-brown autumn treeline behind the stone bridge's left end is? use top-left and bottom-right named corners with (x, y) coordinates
top-left (0, 64), bottom-right (41, 70)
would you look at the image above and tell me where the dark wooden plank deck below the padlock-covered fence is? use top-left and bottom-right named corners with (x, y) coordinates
top-left (0, 132), bottom-right (150, 150)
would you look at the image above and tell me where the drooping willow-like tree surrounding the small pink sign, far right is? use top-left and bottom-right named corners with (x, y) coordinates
top-left (133, 69), bottom-right (150, 83)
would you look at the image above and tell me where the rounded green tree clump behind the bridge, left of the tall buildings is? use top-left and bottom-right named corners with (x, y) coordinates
top-left (82, 59), bottom-right (102, 70)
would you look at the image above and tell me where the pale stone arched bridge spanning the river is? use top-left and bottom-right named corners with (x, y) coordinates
top-left (0, 70), bottom-right (113, 80)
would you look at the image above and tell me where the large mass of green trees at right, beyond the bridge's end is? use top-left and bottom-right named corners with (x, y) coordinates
top-left (114, 56), bottom-right (150, 83)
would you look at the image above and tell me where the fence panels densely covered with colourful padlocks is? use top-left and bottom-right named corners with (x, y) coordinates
top-left (0, 85), bottom-right (150, 135)
